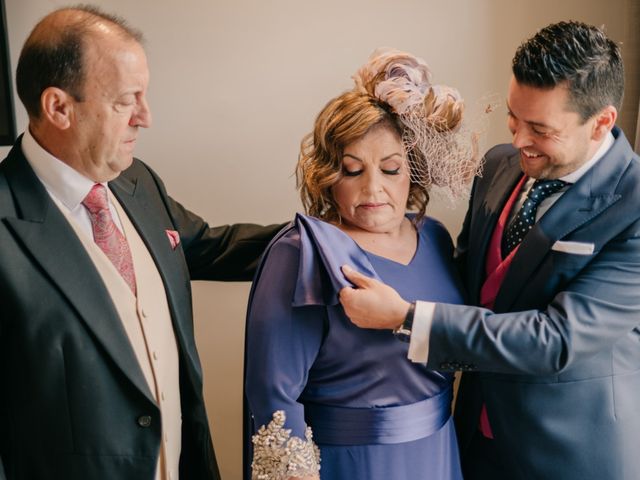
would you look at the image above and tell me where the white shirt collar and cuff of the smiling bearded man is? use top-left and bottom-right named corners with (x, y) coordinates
top-left (407, 132), bottom-right (615, 363)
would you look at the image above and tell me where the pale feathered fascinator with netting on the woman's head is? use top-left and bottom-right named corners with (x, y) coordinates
top-left (353, 48), bottom-right (481, 200)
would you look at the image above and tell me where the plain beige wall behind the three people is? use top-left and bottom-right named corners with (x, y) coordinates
top-left (0, 0), bottom-right (638, 479)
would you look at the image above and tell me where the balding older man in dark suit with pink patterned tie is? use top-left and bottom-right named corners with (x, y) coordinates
top-left (0, 7), bottom-right (278, 480)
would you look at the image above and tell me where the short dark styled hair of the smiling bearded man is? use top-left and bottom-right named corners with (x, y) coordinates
top-left (512, 22), bottom-right (624, 122)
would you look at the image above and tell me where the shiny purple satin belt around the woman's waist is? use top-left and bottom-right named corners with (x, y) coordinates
top-left (304, 388), bottom-right (453, 445)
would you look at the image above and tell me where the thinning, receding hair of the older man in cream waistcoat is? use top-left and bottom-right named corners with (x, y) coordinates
top-left (16, 5), bottom-right (142, 118)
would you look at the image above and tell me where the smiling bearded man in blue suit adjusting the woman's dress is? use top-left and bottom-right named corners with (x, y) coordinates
top-left (341, 22), bottom-right (640, 480)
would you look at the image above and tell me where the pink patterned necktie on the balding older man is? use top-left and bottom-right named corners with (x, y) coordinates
top-left (82, 183), bottom-right (136, 295)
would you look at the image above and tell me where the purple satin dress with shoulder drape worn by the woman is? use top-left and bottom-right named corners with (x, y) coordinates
top-left (245, 215), bottom-right (463, 480)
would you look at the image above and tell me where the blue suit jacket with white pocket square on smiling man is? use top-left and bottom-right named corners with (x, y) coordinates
top-left (428, 129), bottom-right (640, 480)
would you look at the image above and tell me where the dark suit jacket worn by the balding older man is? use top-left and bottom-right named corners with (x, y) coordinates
top-left (0, 140), bottom-right (279, 480)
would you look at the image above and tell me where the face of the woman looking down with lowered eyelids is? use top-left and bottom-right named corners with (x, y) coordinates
top-left (332, 126), bottom-right (410, 233)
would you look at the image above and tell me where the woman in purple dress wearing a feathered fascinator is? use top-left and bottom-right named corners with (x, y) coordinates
top-left (245, 50), bottom-right (478, 480)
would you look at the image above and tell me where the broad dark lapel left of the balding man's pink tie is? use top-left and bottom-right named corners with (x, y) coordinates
top-left (3, 149), bottom-right (154, 402)
